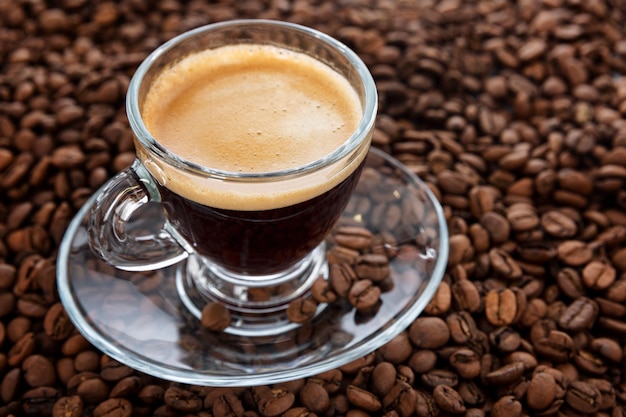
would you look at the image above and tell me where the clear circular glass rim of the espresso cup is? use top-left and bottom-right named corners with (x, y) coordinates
top-left (126, 19), bottom-right (378, 180)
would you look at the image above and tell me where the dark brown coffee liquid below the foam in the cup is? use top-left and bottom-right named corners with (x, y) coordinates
top-left (160, 164), bottom-right (362, 274)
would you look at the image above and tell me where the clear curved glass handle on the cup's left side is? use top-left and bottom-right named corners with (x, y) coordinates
top-left (88, 160), bottom-right (189, 271)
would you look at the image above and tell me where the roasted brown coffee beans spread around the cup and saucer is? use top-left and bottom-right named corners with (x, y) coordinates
top-left (0, 0), bottom-right (626, 417)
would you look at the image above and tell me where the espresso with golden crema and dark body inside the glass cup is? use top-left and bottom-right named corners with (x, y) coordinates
top-left (139, 45), bottom-right (369, 275)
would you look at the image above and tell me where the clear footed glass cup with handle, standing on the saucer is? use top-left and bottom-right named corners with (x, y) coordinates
top-left (89, 20), bottom-right (377, 333)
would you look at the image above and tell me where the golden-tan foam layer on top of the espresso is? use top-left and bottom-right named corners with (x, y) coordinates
top-left (142, 45), bottom-right (364, 210)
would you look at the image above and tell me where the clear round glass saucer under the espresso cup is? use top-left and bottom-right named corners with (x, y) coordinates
top-left (57, 149), bottom-right (448, 386)
